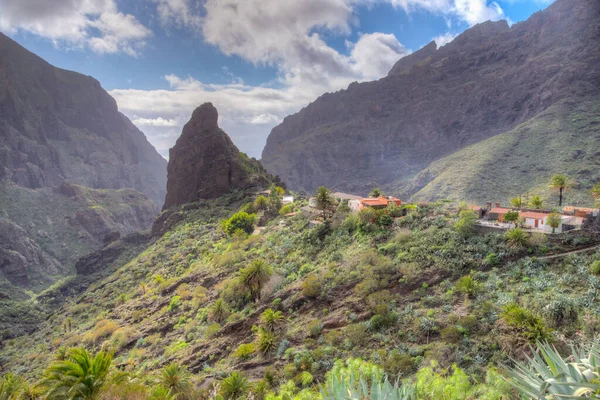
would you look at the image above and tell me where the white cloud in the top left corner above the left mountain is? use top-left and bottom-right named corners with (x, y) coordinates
top-left (0, 0), bottom-right (152, 56)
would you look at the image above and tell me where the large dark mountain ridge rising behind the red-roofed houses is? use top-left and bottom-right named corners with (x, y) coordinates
top-left (261, 0), bottom-right (600, 197)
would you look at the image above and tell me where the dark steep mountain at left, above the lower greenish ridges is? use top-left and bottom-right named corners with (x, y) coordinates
top-left (0, 34), bottom-right (167, 207)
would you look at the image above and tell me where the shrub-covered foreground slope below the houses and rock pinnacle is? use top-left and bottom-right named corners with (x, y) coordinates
top-left (0, 189), bottom-right (600, 399)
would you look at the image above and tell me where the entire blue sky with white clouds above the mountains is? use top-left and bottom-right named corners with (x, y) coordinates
top-left (0, 0), bottom-right (553, 158)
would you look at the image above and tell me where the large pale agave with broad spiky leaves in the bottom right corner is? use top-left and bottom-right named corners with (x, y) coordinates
top-left (508, 341), bottom-right (600, 399)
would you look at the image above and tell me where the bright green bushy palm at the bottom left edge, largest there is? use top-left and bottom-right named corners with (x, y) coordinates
top-left (42, 347), bottom-right (113, 400)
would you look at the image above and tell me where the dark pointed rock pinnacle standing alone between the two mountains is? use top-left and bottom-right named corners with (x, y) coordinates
top-left (163, 103), bottom-right (276, 209)
